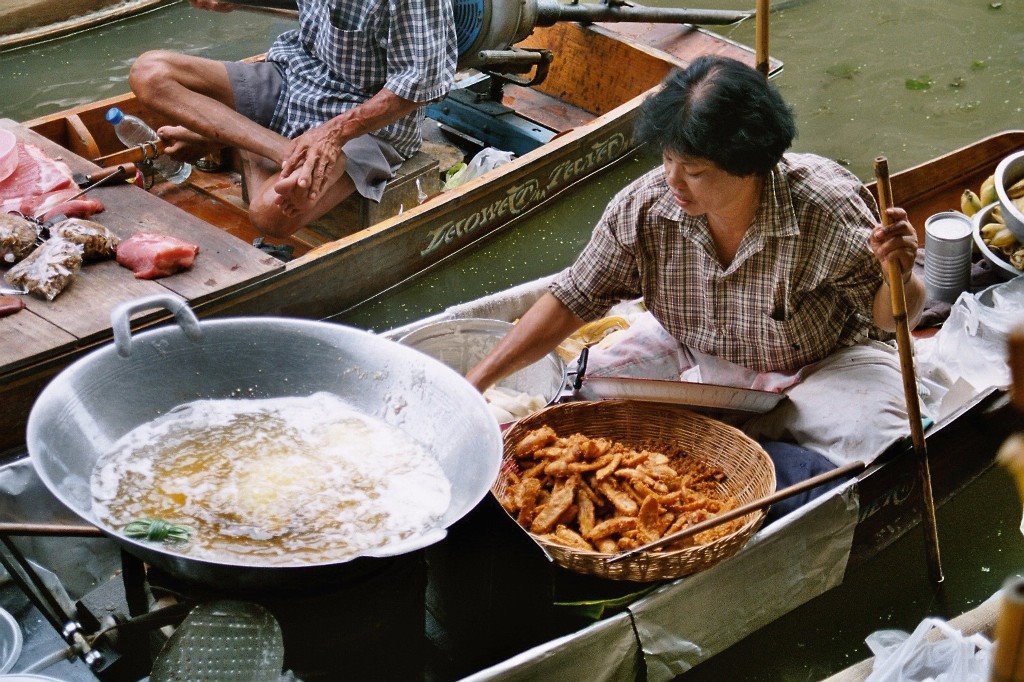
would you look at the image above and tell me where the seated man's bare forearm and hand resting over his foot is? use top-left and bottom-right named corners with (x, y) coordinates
top-left (281, 88), bottom-right (422, 201)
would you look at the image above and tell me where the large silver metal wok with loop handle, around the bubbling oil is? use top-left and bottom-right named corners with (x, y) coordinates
top-left (28, 296), bottom-right (502, 589)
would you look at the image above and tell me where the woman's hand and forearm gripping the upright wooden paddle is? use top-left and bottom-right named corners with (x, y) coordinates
top-left (869, 207), bottom-right (925, 332)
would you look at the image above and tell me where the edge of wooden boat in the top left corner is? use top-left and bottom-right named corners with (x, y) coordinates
top-left (0, 0), bottom-right (174, 52)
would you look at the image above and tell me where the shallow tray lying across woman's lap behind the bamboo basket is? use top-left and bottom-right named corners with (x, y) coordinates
top-left (584, 376), bottom-right (784, 414)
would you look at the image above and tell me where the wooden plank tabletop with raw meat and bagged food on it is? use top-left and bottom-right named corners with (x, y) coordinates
top-left (0, 120), bottom-right (283, 346)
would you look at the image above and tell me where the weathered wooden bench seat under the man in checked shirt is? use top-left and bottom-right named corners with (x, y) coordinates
top-left (294, 152), bottom-right (441, 247)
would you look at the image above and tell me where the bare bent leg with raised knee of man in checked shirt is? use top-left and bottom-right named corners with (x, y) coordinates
top-left (128, 50), bottom-right (292, 165)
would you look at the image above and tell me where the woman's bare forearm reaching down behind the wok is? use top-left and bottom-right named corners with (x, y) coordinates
top-left (466, 293), bottom-right (584, 392)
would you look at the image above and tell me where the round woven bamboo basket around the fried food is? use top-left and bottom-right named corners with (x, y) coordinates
top-left (490, 400), bottom-right (775, 582)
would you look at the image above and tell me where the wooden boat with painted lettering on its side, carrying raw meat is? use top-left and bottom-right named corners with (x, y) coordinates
top-left (0, 23), bottom-right (780, 452)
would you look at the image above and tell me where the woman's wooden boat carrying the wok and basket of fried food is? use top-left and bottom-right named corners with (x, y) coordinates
top-left (0, 131), bottom-right (1024, 680)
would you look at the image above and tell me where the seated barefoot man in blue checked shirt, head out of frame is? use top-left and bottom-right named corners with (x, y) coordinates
top-left (129, 0), bottom-right (457, 237)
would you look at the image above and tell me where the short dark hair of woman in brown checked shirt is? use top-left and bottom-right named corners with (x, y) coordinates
top-left (636, 55), bottom-right (797, 175)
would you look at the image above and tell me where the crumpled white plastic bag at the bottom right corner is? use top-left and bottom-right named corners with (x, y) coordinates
top-left (864, 619), bottom-right (992, 682)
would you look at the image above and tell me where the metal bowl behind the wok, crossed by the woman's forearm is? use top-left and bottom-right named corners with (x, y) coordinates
top-left (398, 317), bottom-right (565, 404)
